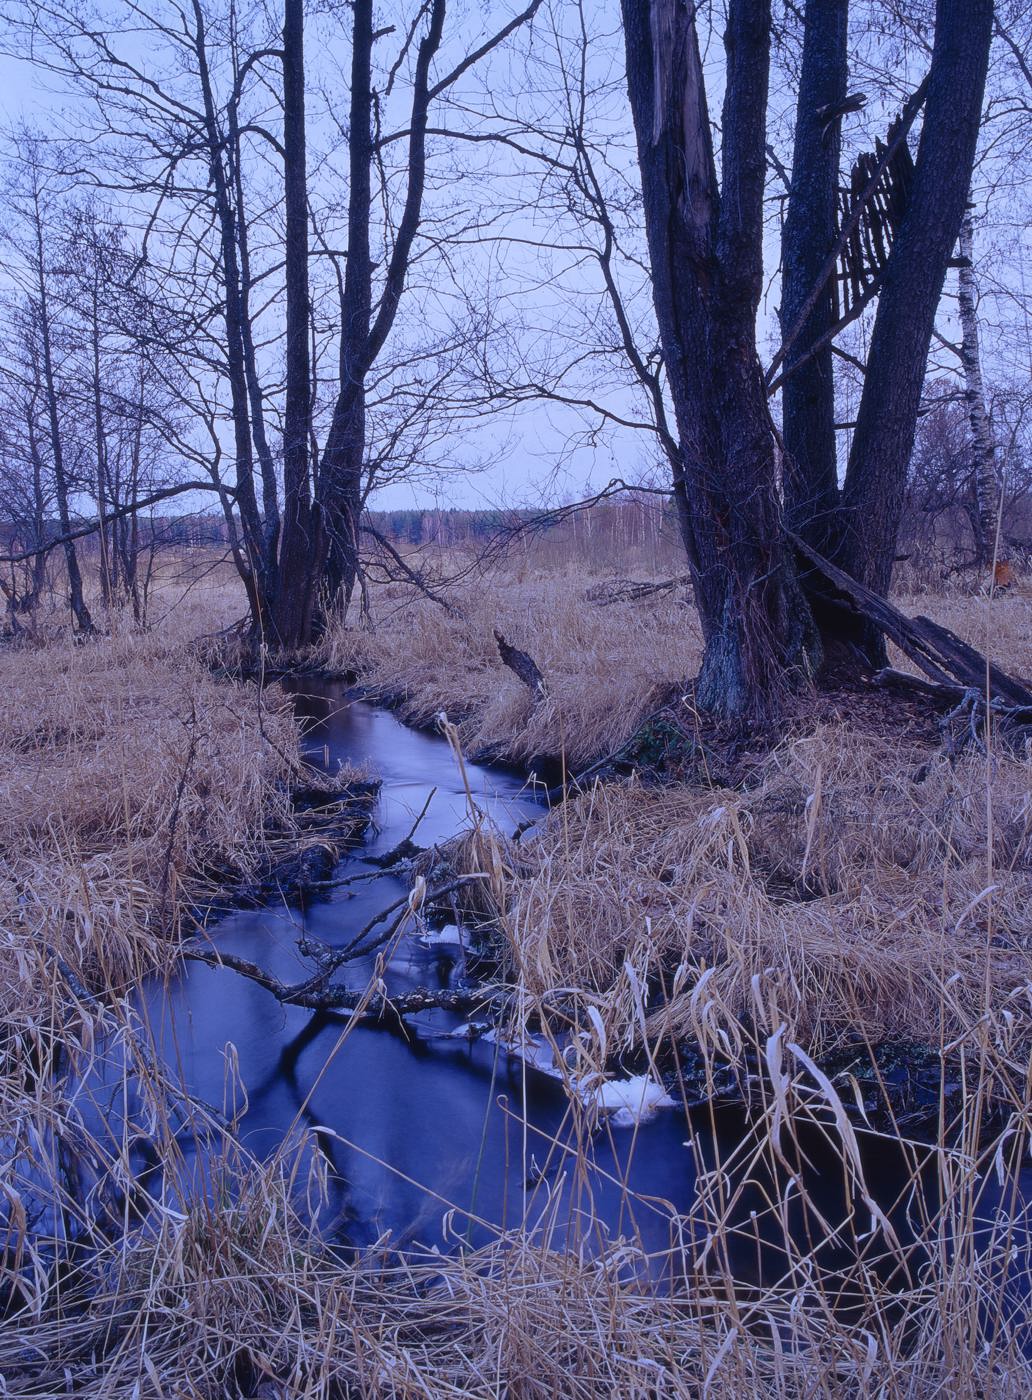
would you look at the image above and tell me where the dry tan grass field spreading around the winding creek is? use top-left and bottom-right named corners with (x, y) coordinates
top-left (0, 538), bottom-right (1032, 1400)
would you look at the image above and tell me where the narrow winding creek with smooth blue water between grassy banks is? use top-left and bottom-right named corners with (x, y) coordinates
top-left (122, 682), bottom-right (1028, 1296)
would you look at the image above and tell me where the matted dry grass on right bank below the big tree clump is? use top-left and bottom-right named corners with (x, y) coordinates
top-left (481, 727), bottom-right (1032, 1054)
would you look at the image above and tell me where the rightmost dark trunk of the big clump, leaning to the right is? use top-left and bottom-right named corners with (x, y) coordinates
top-left (839, 0), bottom-right (993, 624)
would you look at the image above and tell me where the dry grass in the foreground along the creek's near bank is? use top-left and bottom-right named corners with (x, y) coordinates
top-left (0, 985), bottom-right (1032, 1400)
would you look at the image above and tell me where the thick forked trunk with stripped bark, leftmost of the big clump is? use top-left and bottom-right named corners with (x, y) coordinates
top-left (622, 0), bottom-right (811, 720)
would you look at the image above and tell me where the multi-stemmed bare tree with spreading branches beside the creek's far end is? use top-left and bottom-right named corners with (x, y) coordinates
top-left (0, 0), bottom-right (541, 647)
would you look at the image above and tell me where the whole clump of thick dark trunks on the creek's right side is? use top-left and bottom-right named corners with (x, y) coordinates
top-left (623, 0), bottom-right (993, 720)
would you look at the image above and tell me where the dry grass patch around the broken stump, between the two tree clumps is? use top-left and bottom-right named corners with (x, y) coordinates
top-left (326, 574), bottom-right (702, 769)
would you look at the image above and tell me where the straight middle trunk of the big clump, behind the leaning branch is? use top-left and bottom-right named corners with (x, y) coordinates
top-left (780, 0), bottom-right (849, 554)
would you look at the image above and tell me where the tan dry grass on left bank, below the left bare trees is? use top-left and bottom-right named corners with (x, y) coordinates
top-left (0, 627), bottom-right (298, 1016)
